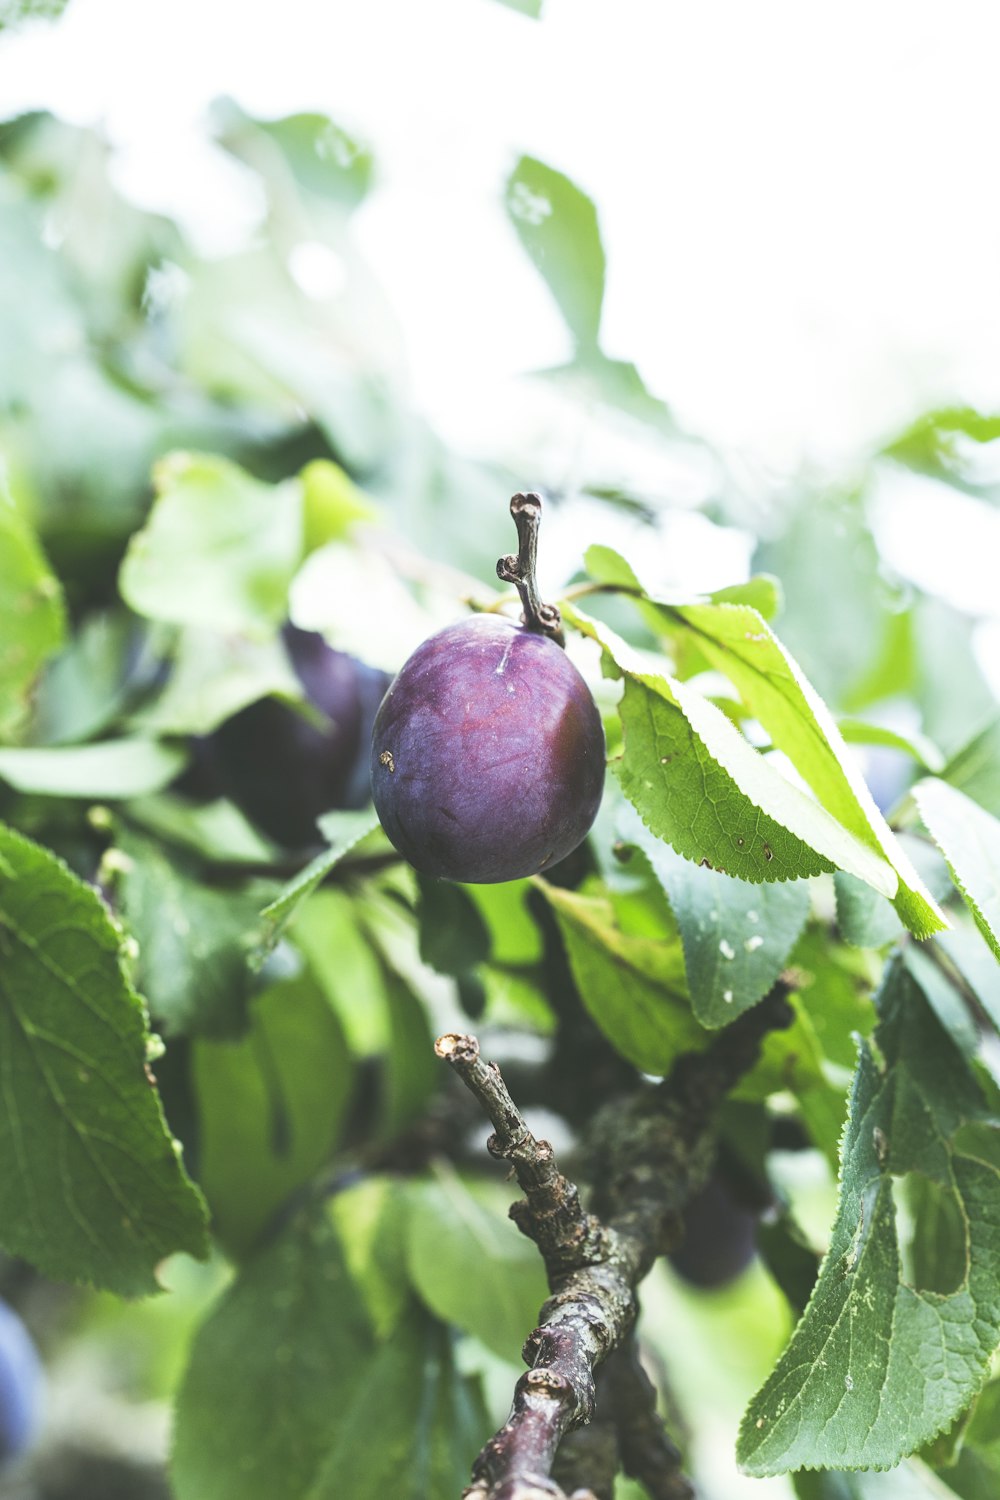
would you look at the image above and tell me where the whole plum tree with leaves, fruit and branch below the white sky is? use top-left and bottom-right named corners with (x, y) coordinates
top-left (0, 93), bottom-right (1000, 1500)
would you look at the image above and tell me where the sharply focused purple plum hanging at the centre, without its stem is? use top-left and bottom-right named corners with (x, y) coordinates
top-left (372, 615), bottom-right (604, 885)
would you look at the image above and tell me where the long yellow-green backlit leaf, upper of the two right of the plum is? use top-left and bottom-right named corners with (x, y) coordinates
top-left (578, 558), bottom-right (948, 938)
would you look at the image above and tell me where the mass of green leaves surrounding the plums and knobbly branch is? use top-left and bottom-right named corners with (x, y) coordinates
top-left (0, 93), bottom-right (1000, 1500)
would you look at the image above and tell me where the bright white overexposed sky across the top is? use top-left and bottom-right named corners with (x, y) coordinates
top-left (0, 0), bottom-right (1000, 468)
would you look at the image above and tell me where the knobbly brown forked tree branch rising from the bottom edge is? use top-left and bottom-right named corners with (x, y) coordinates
top-left (435, 984), bottom-right (792, 1500)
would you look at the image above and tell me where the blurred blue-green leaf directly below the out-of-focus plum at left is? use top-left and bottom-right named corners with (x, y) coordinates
top-left (118, 834), bottom-right (259, 1038)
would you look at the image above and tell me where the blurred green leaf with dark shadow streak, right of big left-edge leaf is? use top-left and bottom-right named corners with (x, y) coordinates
top-left (193, 971), bottom-right (352, 1254)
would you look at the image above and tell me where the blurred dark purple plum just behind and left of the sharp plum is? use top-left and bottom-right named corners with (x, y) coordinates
top-left (195, 626), bottom-right (390, 849)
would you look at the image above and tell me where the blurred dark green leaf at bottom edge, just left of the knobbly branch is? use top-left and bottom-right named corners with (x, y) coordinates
top-left (305, 1313), bottom-right (492, 1500)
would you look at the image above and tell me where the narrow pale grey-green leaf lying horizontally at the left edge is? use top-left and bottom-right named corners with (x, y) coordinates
top-left (0, 738), bottom-right (187, 801)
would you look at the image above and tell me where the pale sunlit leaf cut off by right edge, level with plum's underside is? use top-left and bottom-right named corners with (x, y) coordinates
top-left (913, 777), bottom-right (1000, 959)
